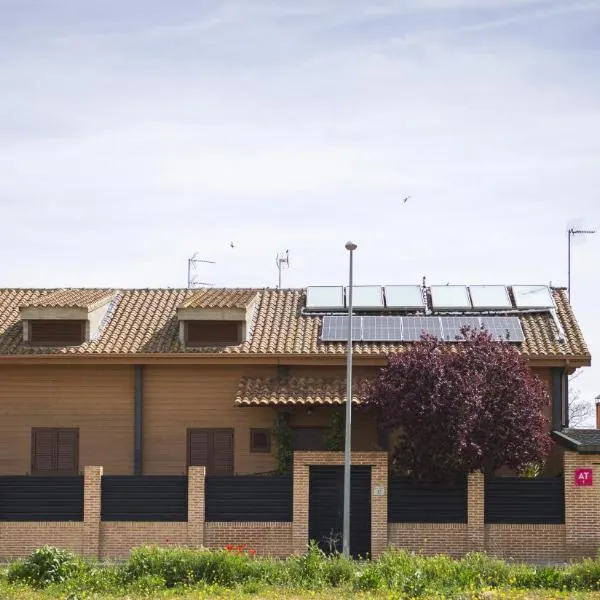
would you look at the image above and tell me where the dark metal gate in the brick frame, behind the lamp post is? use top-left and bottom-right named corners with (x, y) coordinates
top-left (308, 466), bottom-right (371, 558)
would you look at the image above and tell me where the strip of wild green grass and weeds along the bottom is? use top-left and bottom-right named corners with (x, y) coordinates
top-left (5, 546), bottom-right (600, 600)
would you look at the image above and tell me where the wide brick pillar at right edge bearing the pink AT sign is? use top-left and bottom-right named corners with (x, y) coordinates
top-left (564, 450), bottom-right (600, 560)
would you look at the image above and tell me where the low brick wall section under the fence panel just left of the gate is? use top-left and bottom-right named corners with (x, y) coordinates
top-left (204, 522), bottom-right (292, 556)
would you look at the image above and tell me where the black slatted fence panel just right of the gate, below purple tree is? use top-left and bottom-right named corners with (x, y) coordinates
top-left (388, 477), bottom-right (467, 523)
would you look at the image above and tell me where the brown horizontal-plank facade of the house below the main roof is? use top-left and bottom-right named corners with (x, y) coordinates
top-left (0, 364), bottom-right (551, 475)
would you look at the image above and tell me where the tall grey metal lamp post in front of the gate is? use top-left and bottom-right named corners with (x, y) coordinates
top-left (342, 242), bottom-right (357, 556)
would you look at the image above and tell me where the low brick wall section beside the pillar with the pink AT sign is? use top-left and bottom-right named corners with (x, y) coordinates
top-left (485, 525), bottom-right (566, 563)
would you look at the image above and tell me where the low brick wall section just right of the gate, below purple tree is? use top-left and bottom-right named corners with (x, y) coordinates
top-left (388, 523), bottom-right (470, 558)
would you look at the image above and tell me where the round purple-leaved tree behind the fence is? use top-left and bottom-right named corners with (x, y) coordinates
top-left (364, 329), bottom-right (552, 480)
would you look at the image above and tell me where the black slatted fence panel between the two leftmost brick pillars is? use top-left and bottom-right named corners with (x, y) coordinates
top-left (102, 475), bottom-right (187, 521)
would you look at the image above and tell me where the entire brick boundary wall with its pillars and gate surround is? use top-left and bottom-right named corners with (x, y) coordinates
top-left (0, 452), bottom-right (600, 563)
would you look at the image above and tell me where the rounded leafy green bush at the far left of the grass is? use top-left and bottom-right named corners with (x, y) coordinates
top-left (8, 546), bottom-right (88, 588)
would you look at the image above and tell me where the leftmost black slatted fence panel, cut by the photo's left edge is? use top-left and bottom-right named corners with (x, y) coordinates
top-left (0, 475), bottom-right (83, 521)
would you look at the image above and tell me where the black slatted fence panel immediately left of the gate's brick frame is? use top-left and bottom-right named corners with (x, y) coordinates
top-left (205, 475), bottom-right (293, 522)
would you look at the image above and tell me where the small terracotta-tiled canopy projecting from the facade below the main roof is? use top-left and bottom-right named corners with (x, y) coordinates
top-left (235, 377), bottom-right (361, 406)
